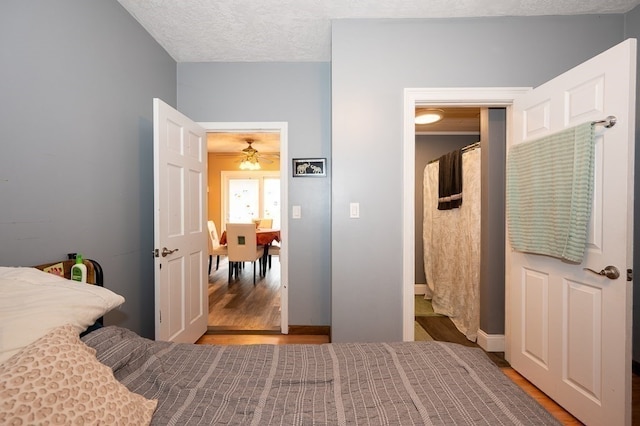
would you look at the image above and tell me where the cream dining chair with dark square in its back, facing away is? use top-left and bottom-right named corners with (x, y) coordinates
top-left (227, 223), bottom-right (264, 285)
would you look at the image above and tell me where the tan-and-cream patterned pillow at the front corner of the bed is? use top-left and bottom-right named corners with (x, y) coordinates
top-left (0, 325), bottom-right (158, 425)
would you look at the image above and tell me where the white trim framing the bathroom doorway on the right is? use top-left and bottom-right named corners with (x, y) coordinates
top-left (402, 87), bottom-right (531, 342)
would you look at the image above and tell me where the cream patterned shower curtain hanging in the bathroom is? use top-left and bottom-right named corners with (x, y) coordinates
top-left (423, 147), bottom-right (480, 341)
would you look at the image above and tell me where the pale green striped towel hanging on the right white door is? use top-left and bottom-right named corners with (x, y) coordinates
top-left (506, 122), bottom-right (595, 263)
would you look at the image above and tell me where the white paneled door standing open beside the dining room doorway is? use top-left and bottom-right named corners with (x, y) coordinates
top-left (153, 99), bottom-right (208, 343)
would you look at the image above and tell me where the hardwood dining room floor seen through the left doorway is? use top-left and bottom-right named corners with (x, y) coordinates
top-left (207, 256), bottom-right (280, 332)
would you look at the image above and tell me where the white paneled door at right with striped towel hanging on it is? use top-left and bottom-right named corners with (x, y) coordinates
top-left (506, 39), bottom-right (636, 425)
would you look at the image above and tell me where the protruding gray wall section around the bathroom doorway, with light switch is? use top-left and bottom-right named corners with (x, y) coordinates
top-left (331, 15), bottom-right (624, 341)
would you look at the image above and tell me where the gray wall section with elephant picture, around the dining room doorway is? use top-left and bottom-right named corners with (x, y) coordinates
top-left (178, 63), bottom-right (331, 325)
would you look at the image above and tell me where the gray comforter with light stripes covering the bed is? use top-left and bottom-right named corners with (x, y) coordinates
top-left (82, 327), bottom-right (558, 426)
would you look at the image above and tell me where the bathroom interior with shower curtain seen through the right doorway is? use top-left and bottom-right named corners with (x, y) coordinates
top-left (414, 107), bottom-right (480, 342)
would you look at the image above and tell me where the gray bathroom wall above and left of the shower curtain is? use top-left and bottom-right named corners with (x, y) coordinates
top-left (414, 135), bottom-right (480, 284)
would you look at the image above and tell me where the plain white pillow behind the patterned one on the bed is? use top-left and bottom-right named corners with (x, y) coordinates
top-left (0, 267), bottom-right (124, 363)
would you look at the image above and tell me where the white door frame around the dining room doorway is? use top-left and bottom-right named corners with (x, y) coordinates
top-left (198, 122), bottom-right (291, 334)
